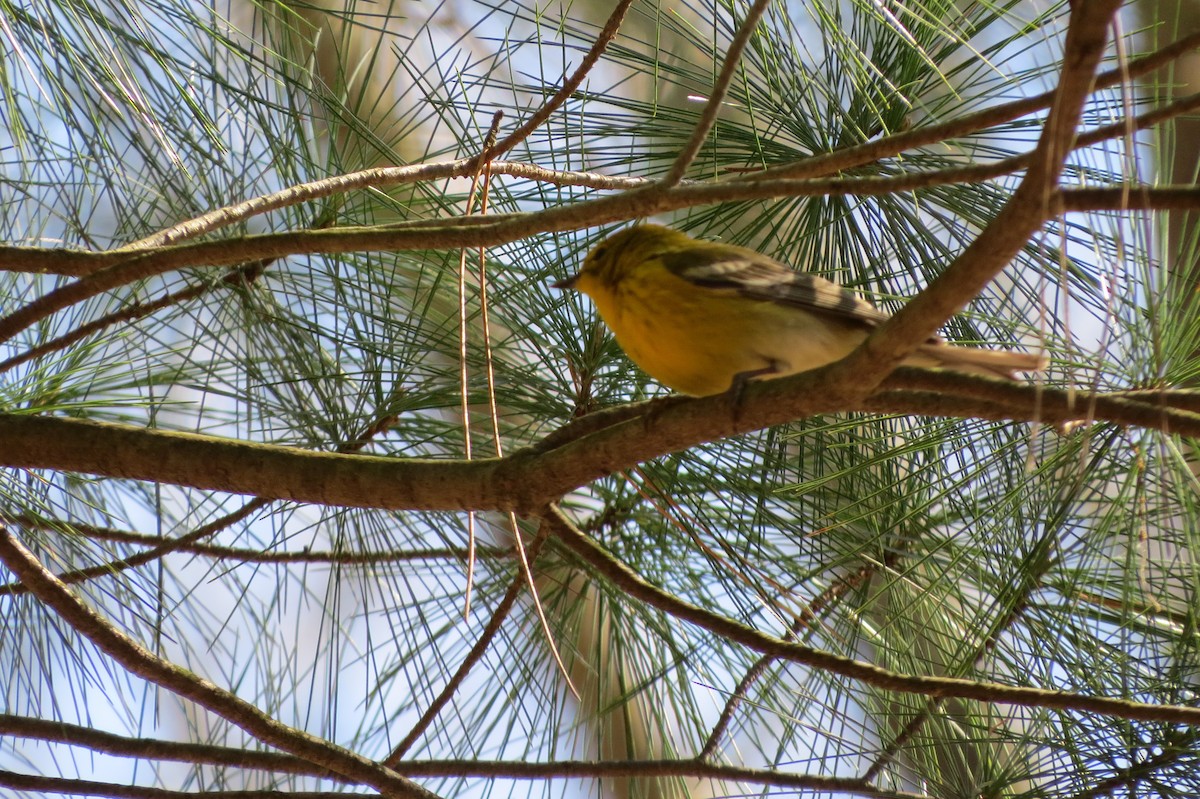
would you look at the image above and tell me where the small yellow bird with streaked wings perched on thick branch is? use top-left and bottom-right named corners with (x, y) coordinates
top-left (554, 224), bottom-right (1045, 396)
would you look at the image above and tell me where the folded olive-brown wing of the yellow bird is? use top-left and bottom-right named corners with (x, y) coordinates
top-left (661, 246), bottom-right (902, 328)
